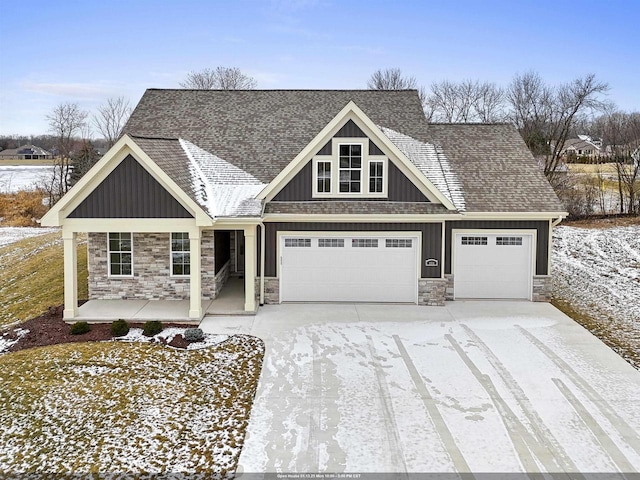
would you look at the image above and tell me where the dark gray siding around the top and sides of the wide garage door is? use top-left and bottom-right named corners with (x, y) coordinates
top-left (264, 222), bottom-right (442, 278)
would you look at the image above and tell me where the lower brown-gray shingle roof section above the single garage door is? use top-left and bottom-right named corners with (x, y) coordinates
top-left (427, 124), bottom-right (564, 212)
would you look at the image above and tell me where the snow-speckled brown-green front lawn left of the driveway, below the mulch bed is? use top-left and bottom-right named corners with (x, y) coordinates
top-left (0, 332), bottom-right (264, 478)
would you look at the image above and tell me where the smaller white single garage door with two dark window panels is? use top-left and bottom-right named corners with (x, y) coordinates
top-left (453, 233), bottom-right (533, 299)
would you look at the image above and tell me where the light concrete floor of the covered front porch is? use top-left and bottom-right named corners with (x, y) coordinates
top-left (73, 277), bottom-right (251, 324)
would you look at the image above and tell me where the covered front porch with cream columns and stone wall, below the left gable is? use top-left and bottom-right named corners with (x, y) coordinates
top-left (62, 219), bottom-right (257, 323)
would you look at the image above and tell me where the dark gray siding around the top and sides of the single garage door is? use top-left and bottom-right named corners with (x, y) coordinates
top-left (444, 220), bottom-right (549, 275)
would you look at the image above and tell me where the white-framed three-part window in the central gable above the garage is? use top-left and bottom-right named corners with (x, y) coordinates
top-left (313, 137), bottom-right (388, 198)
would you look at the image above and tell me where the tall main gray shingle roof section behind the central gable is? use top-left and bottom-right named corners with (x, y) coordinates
top-left (124, 89), bottom-right (427, 183)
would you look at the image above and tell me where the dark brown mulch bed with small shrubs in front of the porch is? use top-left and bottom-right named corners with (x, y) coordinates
top-left (0, 305), bottom-right (195, 352)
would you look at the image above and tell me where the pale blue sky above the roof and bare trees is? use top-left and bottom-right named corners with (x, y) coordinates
top-left (0, 0), bottom-right (640, 134)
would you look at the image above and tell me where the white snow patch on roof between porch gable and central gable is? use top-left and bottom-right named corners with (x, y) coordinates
top-left (180, 139), bottom-right (266, 217)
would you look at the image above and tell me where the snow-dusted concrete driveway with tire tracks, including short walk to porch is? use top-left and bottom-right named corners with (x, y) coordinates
top-left (203, 301), bottom-right (640, 474)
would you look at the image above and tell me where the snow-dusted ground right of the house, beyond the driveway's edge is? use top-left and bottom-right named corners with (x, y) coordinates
top-left (552, 225), bottom-right (640, 369)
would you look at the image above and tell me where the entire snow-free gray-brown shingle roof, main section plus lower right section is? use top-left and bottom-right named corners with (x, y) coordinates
top-left (124, 89), bottom-right (564, 216)
